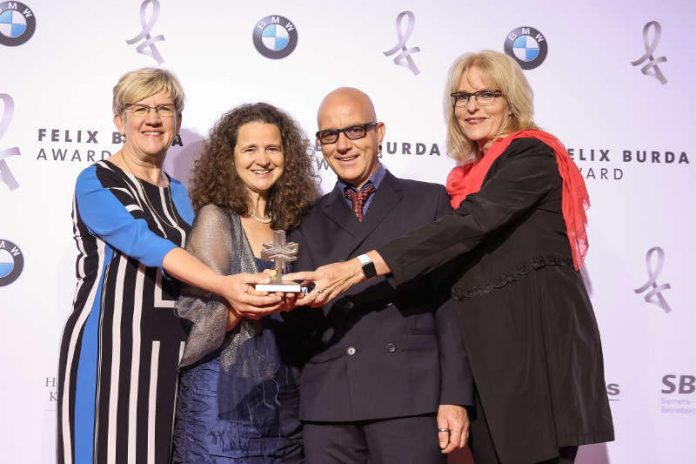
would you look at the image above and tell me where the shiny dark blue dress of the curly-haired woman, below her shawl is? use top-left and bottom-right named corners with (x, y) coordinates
top-left (172, 259), bottom-right (304, 464)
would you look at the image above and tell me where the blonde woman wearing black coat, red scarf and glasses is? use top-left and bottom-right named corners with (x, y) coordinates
top-left (288, 51), bottom-right (614, 464)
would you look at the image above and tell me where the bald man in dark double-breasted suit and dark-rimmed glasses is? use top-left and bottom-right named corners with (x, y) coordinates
top-left (290, 88), bottom-right (473, 464)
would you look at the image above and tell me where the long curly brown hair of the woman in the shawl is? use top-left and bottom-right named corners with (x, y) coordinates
top-left (191, 103), bottom-right (319, 230)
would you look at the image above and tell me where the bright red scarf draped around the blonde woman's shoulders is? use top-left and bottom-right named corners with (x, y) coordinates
top-left (447, 129), bottom-right (590, 270)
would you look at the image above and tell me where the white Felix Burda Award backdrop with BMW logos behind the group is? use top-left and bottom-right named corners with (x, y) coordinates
top-left (0, 0), bottom-right (696, 464)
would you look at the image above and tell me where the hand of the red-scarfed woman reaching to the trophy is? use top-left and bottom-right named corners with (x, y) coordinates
top-left (283, 259), bottom-right (365, 308)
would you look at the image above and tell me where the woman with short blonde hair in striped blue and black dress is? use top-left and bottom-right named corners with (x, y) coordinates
top-left (57, 68), bottom-right (281, 464)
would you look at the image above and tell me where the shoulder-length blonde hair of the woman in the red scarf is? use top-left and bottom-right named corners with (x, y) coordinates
top-left (444, 50), bottom-right (537, 163)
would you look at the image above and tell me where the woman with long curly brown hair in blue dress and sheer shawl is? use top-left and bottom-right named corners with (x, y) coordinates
top-left (173, 103), bottom-right (317, 464)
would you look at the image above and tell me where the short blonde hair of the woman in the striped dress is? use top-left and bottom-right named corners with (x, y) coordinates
top-left (111, 68), bottom-right (184, 115)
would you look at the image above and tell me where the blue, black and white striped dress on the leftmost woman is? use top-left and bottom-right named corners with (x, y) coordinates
top-left (56, 161), bottom-right (193, 464)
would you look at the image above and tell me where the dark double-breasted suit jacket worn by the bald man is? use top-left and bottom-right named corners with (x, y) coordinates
top-left (290, 173), bottom-right (472, 422)
